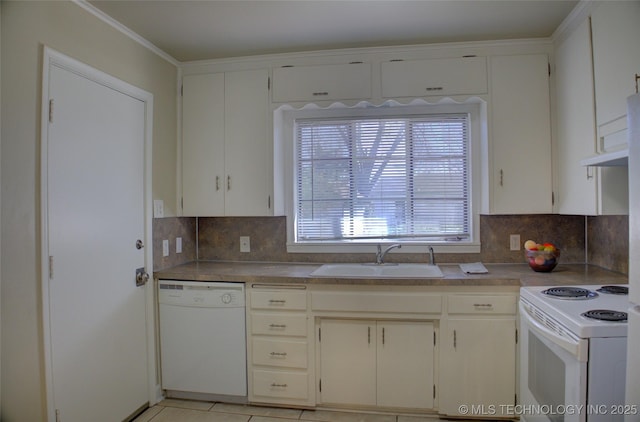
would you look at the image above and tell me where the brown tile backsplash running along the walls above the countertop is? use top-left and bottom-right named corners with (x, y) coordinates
top-left (153, 214), bottom-right (629, 273)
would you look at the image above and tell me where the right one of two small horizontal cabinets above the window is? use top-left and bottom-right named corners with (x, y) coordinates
top-left (381, 57), bottom-right (487, 98)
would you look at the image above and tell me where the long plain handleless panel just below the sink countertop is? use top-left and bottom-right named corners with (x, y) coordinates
top-left (311, 292), bottom-right (442, 314)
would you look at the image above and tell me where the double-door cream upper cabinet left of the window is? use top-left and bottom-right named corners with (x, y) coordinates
top-left (182, 69), bottom-right (272, 216)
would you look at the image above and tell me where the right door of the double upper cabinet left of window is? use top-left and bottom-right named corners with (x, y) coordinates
top-left (224, 69), bottom-right (272, 216)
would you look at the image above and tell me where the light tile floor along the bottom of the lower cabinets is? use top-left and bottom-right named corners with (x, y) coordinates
top-left (134, 399), bottom-right (450, 422)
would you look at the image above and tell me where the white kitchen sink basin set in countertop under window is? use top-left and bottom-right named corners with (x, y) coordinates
top-left (310, 263), bottom-right (443, 278)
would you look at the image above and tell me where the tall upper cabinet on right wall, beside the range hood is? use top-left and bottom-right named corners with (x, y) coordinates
top-left (555, 19), bottom-right (628, 215)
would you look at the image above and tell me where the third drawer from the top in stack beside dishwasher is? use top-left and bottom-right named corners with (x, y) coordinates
top-left (252, 338), bottom-right (307, 368)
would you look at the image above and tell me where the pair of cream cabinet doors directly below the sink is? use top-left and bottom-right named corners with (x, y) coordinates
top-left (319, 319), bottom-right (434, 409)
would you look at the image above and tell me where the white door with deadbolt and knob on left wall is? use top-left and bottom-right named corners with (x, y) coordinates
top-left (43, 52), bottom-right (149, 422)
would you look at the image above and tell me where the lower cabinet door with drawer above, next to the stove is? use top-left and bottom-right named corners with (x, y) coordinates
top-left (438, 295), bottom-right (517, 418)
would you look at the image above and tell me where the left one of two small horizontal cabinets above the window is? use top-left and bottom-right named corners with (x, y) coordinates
top-left (272, 62), bottom-right (371, 103)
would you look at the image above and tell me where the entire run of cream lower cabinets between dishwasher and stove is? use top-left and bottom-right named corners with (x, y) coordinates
top-left (246, 284), bottom-right (517, 419)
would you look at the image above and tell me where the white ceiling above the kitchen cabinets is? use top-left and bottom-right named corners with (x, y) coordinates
top-left (89, 0), bottom-right (578, 62)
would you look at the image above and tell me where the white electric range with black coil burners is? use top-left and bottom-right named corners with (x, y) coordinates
top-left (516, 285), bottom-right (638, 422)
